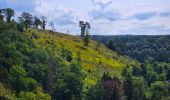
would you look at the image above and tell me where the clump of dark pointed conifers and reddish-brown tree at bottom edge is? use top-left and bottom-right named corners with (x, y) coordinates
top-left (87, 73), bottom-right (124, 100)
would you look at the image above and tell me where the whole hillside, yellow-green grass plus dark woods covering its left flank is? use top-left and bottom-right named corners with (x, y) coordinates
top-left (0, 17), bottom-right (139, 100)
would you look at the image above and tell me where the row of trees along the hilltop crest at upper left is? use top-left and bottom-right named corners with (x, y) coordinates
top-left (0, 8), bottom-right (47, 32)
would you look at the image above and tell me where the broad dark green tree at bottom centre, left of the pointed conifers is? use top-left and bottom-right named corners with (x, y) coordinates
top-left (53, 62), bottom-right (84, 100)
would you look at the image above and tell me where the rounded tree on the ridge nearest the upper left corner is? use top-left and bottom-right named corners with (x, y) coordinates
top-left (3, 8), bottom-right (15, 22)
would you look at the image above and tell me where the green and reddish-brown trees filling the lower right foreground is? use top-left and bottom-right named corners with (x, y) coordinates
top-left (87, 60), bottom-right (170, 100)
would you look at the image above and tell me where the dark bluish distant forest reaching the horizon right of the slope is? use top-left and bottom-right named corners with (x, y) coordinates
top-left (93, 35), bottom-right (170, 62)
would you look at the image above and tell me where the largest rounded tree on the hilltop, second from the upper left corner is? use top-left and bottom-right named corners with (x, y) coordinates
top-left (18, 12), bottom-right (33, 30)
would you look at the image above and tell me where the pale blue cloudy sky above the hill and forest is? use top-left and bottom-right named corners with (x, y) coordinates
top-left (0, 0), bottom-right (170, 35)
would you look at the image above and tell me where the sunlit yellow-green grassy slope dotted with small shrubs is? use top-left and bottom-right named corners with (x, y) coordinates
top-left (27, 30), bottom-right (139, 85)
